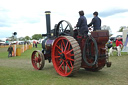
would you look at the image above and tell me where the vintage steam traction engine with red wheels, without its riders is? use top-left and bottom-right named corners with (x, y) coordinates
top-left (31, 11), bottom-right (111, 76)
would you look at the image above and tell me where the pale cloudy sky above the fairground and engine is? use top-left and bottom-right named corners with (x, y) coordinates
top-left (0, 0), bottom-right (128, 38)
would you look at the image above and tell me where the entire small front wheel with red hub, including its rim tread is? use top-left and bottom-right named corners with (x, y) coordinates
top-left (31, 50), bottom-right (45, 70)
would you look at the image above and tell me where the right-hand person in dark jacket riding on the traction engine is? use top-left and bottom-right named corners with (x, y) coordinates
top-left (88, 12), bottom-right (101, 31)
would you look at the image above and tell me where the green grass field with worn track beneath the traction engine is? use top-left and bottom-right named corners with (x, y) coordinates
top-left (0, 45), bottom-right (128, 85)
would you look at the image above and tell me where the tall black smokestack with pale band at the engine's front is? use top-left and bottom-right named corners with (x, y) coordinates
top-left (45, 11), bottom-right (51, 37)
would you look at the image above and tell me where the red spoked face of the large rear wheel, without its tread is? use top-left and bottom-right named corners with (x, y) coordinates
top-left (52, 37), bottom-right (74, 76)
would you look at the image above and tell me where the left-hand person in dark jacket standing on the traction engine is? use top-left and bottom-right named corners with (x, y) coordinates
top-left (75, 11), bottom-right (88, 35)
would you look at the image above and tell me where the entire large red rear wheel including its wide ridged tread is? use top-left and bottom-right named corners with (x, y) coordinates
top-left (52, 36), bottom-right (81, 76)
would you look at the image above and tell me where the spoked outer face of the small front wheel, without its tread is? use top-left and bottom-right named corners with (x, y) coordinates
top-left (31, 51), bottom-right (43, 70)
